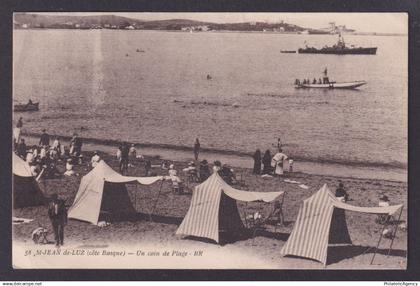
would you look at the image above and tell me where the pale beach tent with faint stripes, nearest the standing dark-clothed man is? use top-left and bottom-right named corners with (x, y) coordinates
top-left (68, 160), bottom-right (162, 225)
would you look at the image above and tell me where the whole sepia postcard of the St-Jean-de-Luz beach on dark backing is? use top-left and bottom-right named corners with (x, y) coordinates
top-left (12, 12), bottom-right (406, 270)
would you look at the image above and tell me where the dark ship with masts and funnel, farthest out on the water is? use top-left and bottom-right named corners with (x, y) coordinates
top-left (298, 34), bottom-right (378, 55)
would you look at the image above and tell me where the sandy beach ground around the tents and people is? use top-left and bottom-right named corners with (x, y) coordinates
top-left (13, 137), bottom-right (407, 269)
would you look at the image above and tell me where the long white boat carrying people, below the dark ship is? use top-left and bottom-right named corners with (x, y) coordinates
top-left (295, 68), bottom-right (367, 89)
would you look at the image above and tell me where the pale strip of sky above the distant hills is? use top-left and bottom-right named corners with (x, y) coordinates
top-left (37, 12), bottom-right (408, 34)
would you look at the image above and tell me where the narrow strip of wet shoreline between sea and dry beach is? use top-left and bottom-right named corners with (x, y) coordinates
top-left (21, 132), bottom-right (408, 183)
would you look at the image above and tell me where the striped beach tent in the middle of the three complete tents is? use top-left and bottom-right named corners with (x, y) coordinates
top-left (176, 173), bottom-right (283, 243)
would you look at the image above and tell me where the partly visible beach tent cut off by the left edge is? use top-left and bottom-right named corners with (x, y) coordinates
top-left (12, 153), bottom-right (46, 208)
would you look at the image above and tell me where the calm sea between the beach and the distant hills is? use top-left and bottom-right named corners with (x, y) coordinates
top-left (13, 30), bottom-right (408, 168)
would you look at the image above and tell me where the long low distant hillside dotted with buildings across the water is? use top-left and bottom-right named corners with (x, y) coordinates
top-left (14, 13), bottom-right (305, 32)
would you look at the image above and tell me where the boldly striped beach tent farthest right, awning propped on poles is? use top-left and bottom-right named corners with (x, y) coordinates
top-left (281, 184), bottom-right (403, 265)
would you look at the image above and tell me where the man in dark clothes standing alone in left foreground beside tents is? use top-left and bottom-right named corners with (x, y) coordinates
top-left (48, 194), bottom-right (67, 246)
